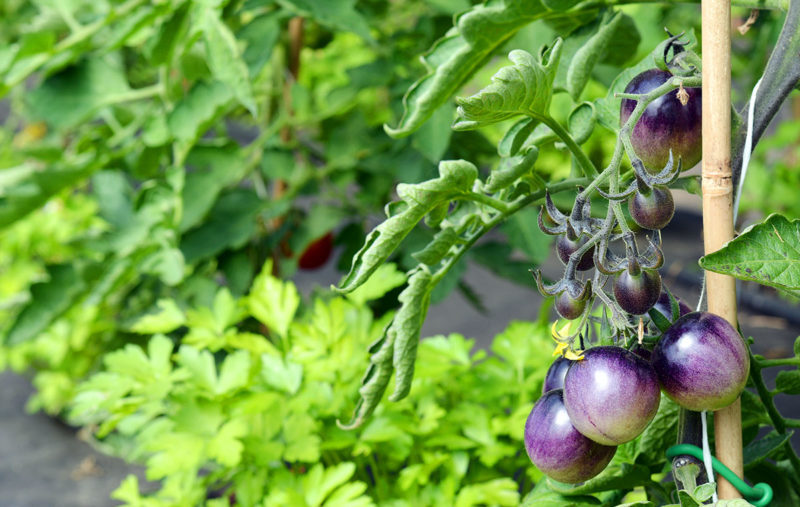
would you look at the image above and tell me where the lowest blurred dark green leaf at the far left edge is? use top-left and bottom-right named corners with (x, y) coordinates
top-left (5, 264), bottom-right (86, 346)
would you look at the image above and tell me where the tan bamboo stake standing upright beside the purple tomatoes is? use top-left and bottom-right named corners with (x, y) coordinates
top-left (701, 0), bottom-right (744, 499)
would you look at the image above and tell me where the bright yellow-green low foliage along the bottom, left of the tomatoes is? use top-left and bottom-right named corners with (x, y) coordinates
top-left (69, 263), bottom-right (550, 506)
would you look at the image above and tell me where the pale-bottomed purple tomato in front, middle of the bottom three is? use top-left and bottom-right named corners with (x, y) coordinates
top-left (564, 346), bottom-right (661, 445)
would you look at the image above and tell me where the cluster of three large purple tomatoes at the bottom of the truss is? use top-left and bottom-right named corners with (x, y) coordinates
top-left (525, 298), bottom-right (750, 484)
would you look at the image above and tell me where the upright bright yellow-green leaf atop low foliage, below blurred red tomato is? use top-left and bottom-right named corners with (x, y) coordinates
top-left (247, 259), bottom-right (300, 337)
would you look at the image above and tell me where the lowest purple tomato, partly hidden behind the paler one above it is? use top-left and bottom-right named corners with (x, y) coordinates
top-left (525, 389), bottom-right (617, 484)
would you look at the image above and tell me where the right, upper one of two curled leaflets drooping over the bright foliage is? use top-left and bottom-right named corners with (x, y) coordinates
top-left (387, 268), bottom-right (433, 401)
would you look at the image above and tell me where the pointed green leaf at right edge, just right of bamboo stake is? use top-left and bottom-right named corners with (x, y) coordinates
top-left (700, 214), bottom-right (800, 290)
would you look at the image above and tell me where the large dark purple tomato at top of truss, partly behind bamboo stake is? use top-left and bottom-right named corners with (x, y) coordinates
top-left (620, 69), bottom-right (702, 173)
